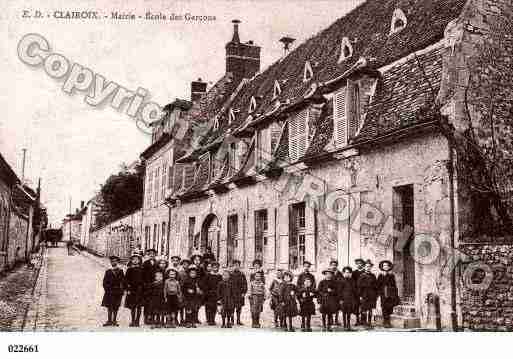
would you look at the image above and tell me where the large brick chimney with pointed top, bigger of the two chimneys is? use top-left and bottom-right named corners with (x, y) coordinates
top-left (226, 20), bottom-right (260, 86)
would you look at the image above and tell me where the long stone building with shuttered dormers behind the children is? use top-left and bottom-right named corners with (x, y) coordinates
top-left (132, 0), bottom-right (511, 327)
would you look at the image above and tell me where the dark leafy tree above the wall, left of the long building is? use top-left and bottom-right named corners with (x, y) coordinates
top-left (96, 163), bottom-right (144, 227)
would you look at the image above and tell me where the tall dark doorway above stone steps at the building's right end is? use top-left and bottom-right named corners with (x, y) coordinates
top-left (393, 184), bottom-right (415, 304)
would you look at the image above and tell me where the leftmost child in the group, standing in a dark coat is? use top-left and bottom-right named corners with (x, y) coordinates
top-left (102, 256), bottom-right (125, 327)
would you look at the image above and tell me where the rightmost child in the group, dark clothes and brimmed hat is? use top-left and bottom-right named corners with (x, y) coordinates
top-left (377, 260), bottom-right (400, 328)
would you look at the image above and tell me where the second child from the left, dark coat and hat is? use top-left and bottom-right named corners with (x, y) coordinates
top-left (125, 254), bottom-right (144, 327)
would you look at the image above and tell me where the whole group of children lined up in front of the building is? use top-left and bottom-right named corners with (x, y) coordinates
top-left (102, 249), bottom-right (399, 331)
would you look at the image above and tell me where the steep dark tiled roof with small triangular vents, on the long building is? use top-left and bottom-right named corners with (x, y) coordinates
top-left (174, 0), bottom-right (467, 197)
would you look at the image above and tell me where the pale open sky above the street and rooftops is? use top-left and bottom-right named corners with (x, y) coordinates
top-left (0, 0), bottom-right (362, 227)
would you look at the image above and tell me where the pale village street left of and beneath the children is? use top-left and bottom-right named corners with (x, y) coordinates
top-left (25, 246), bottom-right (362, 332)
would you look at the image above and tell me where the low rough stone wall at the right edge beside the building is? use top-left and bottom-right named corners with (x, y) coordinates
top-left (460, 238), bottom-right (513, 331)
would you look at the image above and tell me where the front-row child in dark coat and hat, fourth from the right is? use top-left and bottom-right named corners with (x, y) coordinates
top-left (317, 269), bottom-right (339, 332)
